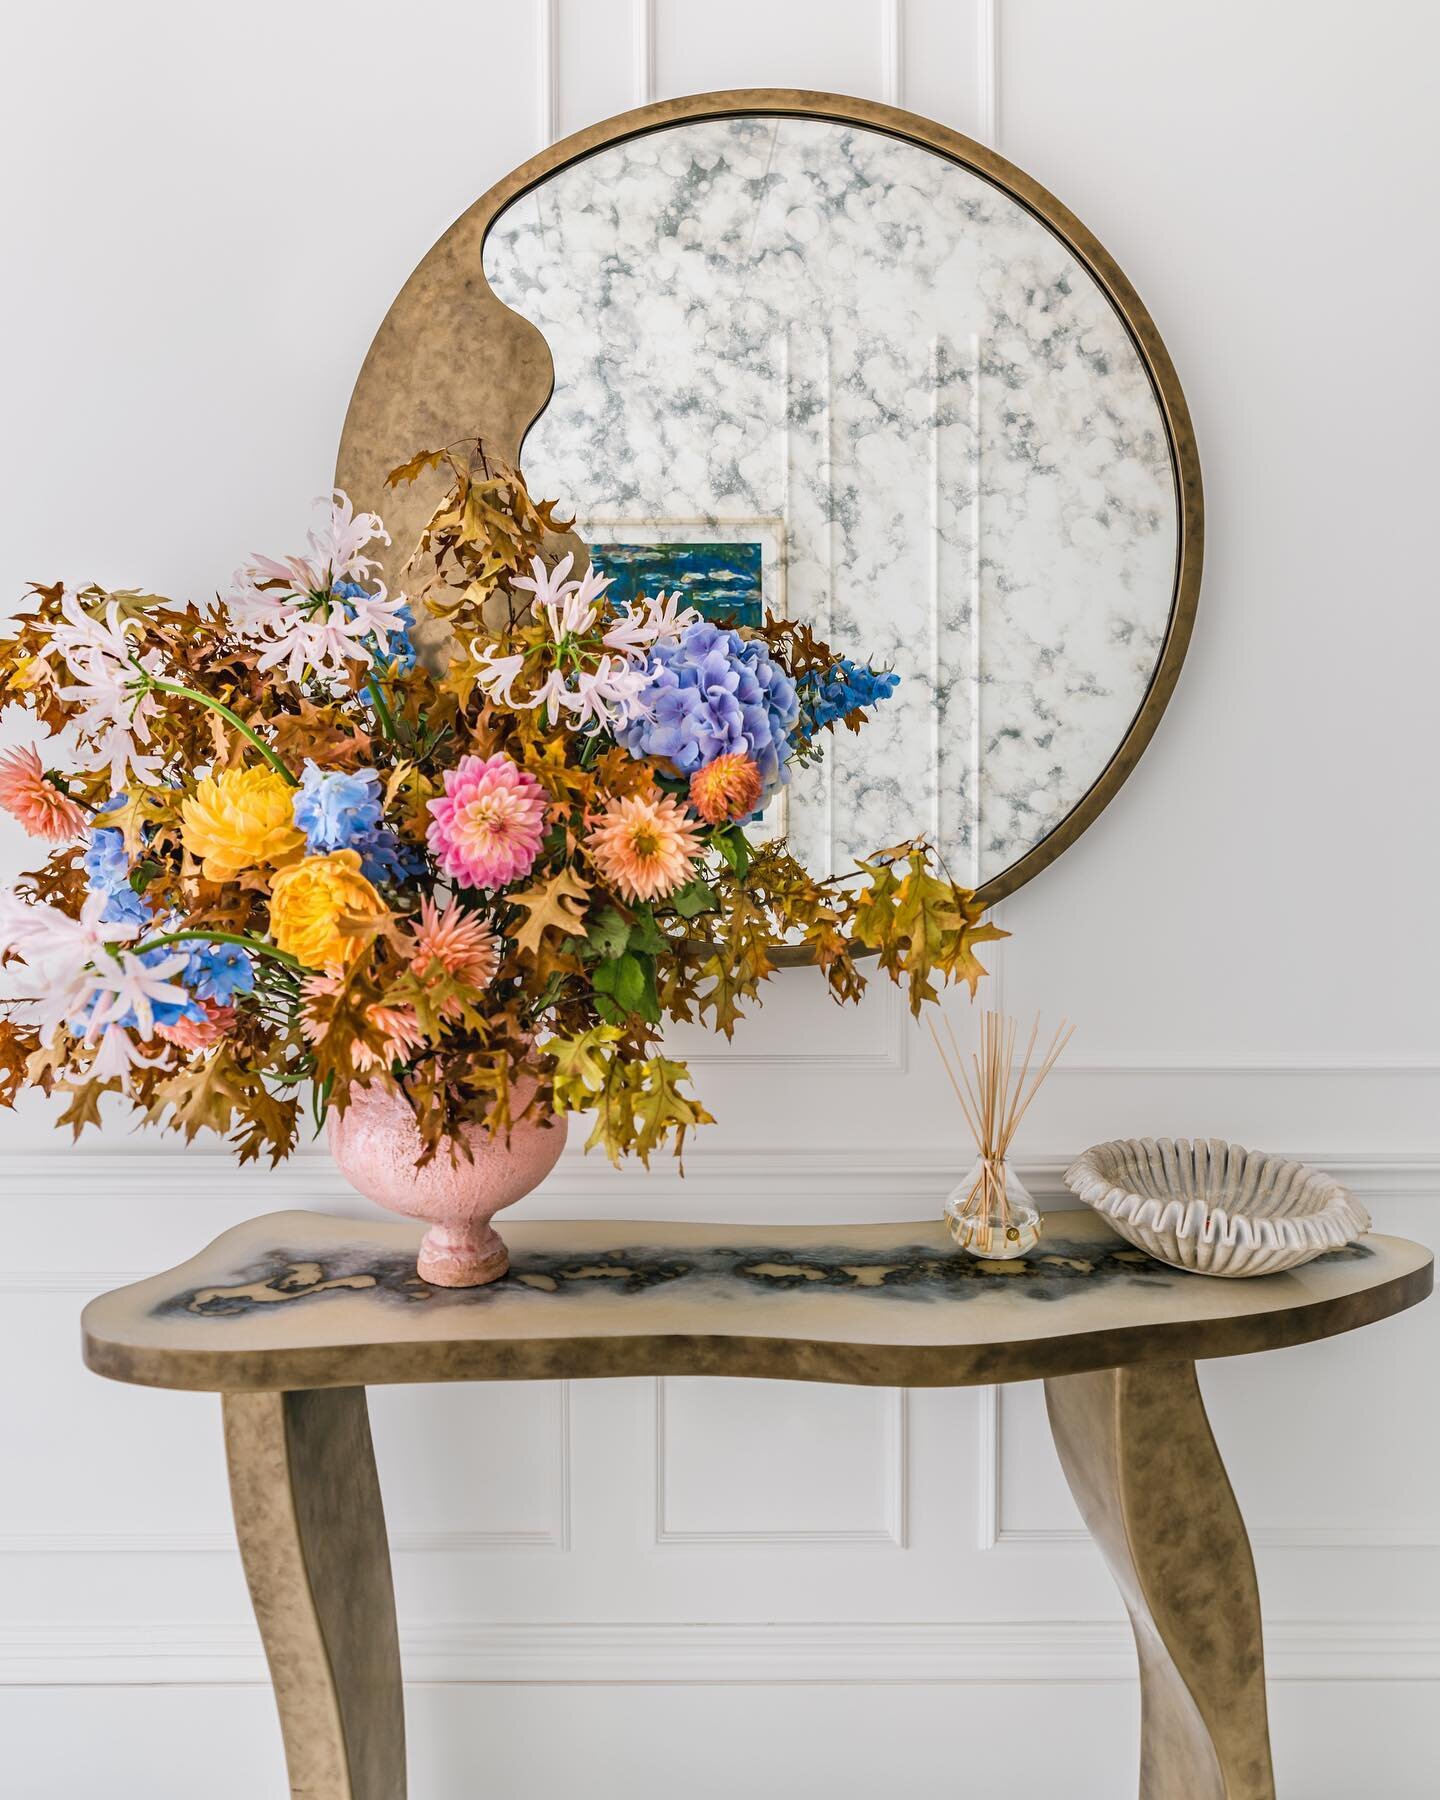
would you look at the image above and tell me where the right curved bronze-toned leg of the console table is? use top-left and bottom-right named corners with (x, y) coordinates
top-left (1046, 1363), bottom-right (1274, 1800)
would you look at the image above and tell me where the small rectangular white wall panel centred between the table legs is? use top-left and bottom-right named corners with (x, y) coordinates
top-left (655, 1379), bottom-right (905, 1550)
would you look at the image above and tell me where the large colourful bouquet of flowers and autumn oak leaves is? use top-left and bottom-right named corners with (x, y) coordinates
top-left (0, 441), bottom-right (1001, 1159)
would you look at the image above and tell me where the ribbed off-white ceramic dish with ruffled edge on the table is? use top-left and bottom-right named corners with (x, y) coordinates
top-left (1066, 1138), bottom-right (1370, 1276)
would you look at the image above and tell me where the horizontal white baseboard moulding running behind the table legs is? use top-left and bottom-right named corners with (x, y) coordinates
top-left (0, 1620), bottom-right (1440, 1687)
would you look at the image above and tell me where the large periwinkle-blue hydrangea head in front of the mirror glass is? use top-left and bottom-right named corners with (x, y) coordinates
top-left (617, 619), bottom-right (799, 794)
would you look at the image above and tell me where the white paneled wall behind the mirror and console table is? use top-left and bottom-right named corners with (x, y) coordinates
top-left (0, 0), bottom-right (1440, 1800)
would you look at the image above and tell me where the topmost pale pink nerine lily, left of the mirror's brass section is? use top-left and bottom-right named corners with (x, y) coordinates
top-left (230, 488), bottom-right (407, 682)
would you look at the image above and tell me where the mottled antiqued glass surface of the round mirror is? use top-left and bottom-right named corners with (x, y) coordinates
top-left (484, 115), bottom-right (1179, 886)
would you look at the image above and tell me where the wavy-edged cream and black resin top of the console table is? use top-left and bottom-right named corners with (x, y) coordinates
top-left (83, 1211), bottom-right (1433, 1393)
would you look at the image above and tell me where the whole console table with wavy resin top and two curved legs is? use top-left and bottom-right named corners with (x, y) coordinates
top-left (83, 1211), bottom-right (1433, 1800)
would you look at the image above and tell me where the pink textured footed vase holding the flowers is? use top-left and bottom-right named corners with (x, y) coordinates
top-left (329, 1084), bottom-right (567, 1287)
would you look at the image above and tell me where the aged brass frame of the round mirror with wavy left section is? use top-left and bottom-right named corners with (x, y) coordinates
top-left (335, 88), bottom-right (1204, 914)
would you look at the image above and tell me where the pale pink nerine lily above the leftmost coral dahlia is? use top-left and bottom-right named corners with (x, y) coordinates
top-left (41, 594), bottom-right (162, 788)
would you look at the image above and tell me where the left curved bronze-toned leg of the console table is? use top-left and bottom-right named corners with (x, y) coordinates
top-left (223, 1388), bottom-right (405, 1800)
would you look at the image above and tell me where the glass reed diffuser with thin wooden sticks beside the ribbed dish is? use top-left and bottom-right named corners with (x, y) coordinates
top-left (931, 1012), bottom-right (1075, 1258)
